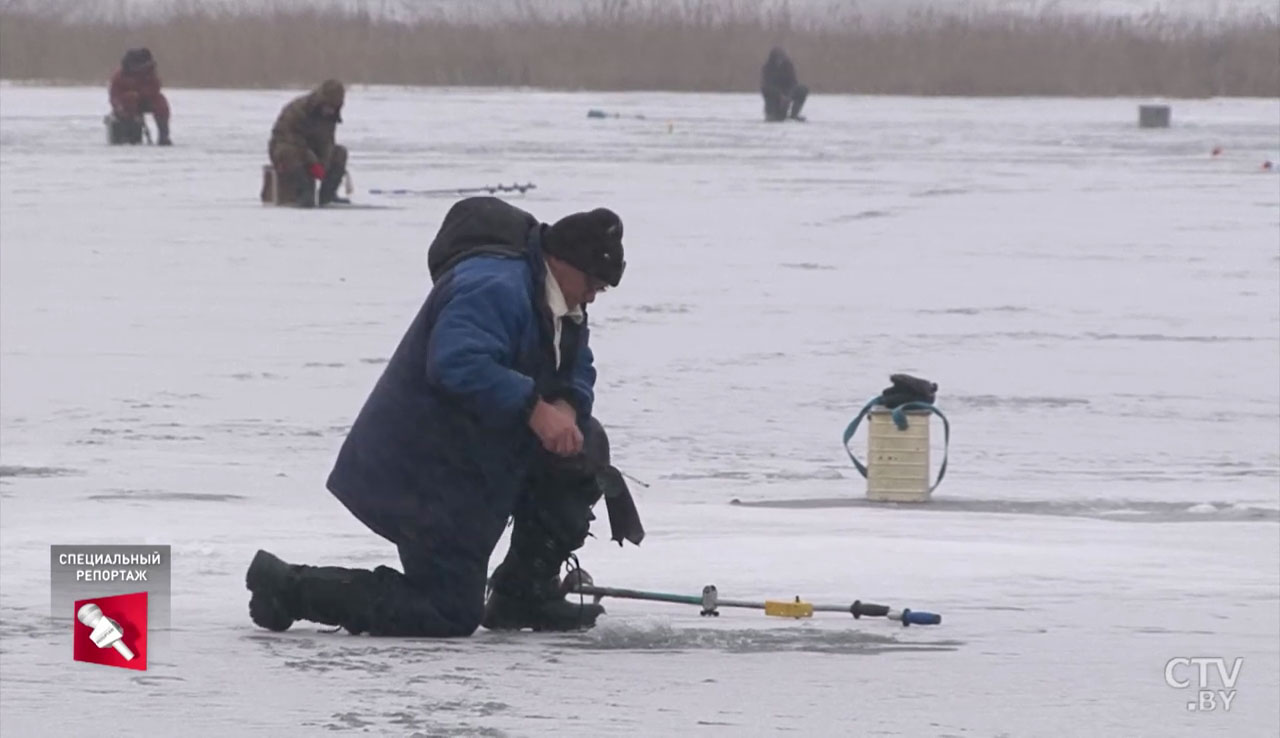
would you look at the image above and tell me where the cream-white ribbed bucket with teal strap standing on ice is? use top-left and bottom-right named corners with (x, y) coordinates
top-left (867, 407), bottom-right (933, 503)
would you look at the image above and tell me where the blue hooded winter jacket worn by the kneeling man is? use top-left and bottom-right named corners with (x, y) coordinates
top-left (328, 197), bottom-right (595, 547)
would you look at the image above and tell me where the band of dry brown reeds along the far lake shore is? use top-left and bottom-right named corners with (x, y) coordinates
top-left (0, 0), bottom-right (1280, 97)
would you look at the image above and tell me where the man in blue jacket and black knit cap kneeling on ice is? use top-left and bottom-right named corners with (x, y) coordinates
top-left (246, 197), bottom-right (644, 637)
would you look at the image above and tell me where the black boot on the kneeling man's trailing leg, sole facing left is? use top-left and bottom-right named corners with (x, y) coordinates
top-left (244, 550), bottom-right (378, 634)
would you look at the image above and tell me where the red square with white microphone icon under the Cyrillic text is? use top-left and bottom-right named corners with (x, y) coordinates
top-left (72, 592), bottom-right (147, 671)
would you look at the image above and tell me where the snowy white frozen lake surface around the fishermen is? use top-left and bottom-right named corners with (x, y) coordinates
top-left (0, 86), bottom-right (1280, 737)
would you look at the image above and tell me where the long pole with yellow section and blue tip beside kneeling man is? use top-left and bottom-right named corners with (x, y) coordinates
top-left (563, 573), bottom-right (942, 627)
